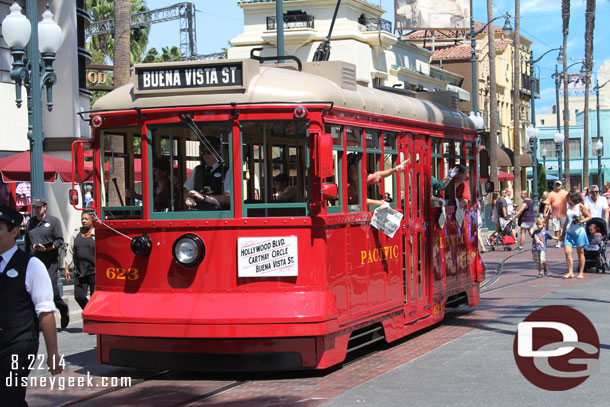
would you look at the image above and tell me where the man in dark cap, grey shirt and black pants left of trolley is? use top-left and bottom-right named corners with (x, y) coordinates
top-left (25, 197), bottom-right (70, 328)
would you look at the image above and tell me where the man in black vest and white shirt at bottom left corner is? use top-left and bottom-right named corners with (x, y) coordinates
top-left (0, 206), bottom-right (63, 407)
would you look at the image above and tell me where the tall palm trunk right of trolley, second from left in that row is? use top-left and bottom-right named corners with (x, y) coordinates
top-left (513, 0), bottom-right (521, 201)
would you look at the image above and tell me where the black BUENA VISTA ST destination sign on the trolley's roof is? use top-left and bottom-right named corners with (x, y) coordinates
top-left (135, 62), bottom-right (244, 93)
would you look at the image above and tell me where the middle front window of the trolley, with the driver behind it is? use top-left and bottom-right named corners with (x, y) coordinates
top-left (149, 119), bottom-right (233, 219)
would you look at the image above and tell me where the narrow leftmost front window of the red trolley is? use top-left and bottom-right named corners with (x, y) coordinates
top-left (100, 126), bottom-right (143, 219)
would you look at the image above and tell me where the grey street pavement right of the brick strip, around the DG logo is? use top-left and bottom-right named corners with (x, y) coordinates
top-left (324, 243), bottom-right (610, 407)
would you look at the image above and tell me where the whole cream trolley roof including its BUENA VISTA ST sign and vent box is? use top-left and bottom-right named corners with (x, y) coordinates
top-left (93, 59), bottom-right (474, 129)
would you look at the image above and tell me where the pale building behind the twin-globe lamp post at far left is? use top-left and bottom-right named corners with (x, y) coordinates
top-left (0, 0), bottom-right (90, 239)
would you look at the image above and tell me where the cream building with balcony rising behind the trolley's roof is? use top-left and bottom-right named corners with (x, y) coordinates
top-left (228, 0), bottom-right (452, 91)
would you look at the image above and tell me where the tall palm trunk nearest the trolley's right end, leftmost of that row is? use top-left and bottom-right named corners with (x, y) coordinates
top-left (487, 0), bottom-right (498, 190)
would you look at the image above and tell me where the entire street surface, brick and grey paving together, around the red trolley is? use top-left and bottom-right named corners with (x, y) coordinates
top-left (28, 244), bottom-right (610, 407)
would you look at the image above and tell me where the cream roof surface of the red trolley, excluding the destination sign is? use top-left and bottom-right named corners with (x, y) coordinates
top-left (93, 63), bottom-right (473, 129)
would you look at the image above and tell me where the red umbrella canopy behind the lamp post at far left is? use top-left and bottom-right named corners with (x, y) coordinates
top-left (0, 151), bottom-right (83, 182)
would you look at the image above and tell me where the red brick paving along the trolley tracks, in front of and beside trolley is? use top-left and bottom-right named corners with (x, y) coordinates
top-left (28, 242), bottom-right (602, 407)
